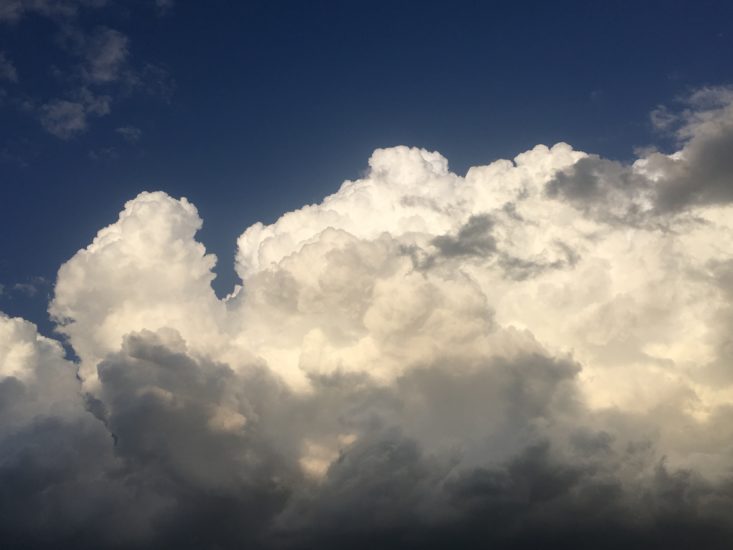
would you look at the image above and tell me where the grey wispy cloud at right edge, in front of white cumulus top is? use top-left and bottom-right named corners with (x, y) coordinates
top-left (549, 87), bottom-right (733, 218)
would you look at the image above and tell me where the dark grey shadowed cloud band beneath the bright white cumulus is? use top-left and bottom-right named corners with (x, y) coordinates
top-left (0, 322), bottom-right (733, 549)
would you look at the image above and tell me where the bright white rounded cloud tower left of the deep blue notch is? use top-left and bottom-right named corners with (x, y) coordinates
top-left (50, 192), bottom-right (225, 386)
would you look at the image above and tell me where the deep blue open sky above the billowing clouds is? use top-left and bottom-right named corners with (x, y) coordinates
top-left (0, 1), bottom-right (733, 332)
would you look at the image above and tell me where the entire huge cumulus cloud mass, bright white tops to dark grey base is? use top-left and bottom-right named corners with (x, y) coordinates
top-left (0, 88), bottom-right (733, 548)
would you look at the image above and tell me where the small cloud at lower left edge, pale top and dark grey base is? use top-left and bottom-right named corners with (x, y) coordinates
top-left (0, 315), bottom-right (127, 544)
